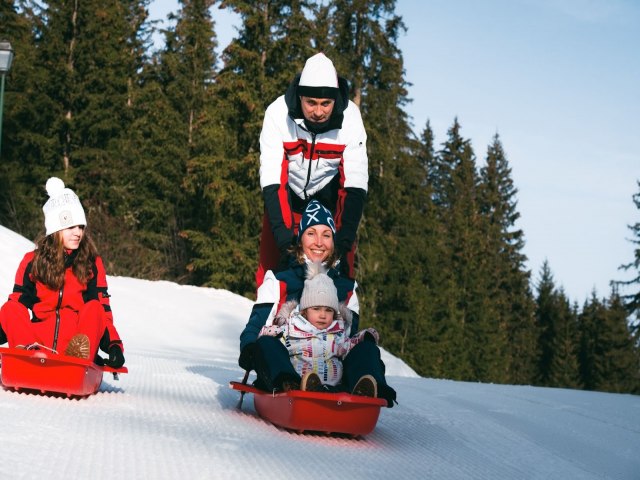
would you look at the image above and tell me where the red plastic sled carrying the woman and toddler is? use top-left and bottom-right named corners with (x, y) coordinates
top-left (229, 382), bottom-right (387, 436)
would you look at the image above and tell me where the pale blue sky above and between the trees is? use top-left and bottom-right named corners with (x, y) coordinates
top-left (150, 0), bottom-right (640, 304)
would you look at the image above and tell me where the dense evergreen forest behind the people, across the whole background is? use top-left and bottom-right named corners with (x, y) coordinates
top-left (0, 0), bottom-right (640, 394)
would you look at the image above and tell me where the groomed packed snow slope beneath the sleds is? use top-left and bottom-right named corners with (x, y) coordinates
top-left (0, 226), bottom-right (640, 480)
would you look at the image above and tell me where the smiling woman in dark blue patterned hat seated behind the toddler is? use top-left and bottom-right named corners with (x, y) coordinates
top-left (238, 200), bottom-right (396, 407)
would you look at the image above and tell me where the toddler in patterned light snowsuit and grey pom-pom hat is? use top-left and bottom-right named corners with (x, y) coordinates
top-left (260, 263), bottom-right (379, 390)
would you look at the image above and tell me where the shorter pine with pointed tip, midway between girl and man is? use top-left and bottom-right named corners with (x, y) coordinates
top-left (114, 67), bottom-right (188, 280)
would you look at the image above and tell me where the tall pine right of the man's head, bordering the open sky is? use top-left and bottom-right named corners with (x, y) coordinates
top-left (327, 0), bottom-right (413, 182)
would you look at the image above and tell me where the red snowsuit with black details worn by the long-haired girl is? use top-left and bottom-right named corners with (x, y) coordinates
top-left (0, 251), bottom-right (124, 359)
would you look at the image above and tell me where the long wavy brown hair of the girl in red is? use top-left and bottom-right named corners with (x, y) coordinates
top-left (32, 229), bottom-right (98, 290)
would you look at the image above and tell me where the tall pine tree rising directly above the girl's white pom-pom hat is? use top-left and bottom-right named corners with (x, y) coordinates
top-left (41, 0), bottom-right (139, 176)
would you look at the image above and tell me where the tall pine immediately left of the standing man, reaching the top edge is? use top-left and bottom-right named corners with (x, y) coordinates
top-left (176, 0), bottom-right (312, 296)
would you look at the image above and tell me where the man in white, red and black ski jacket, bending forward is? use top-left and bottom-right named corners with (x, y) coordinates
top-left (256, 53), bottom-right (369, 286)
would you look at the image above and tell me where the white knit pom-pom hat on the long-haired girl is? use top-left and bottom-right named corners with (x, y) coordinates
top-left (42, 177), bottom-right (87, 235)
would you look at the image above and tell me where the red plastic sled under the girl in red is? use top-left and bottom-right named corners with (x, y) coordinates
top-left (0, 348), bottom-right (128, 397)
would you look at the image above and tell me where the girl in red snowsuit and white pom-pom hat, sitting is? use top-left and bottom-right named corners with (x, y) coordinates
top-left (0, 177), bottom-right (124, 368)
